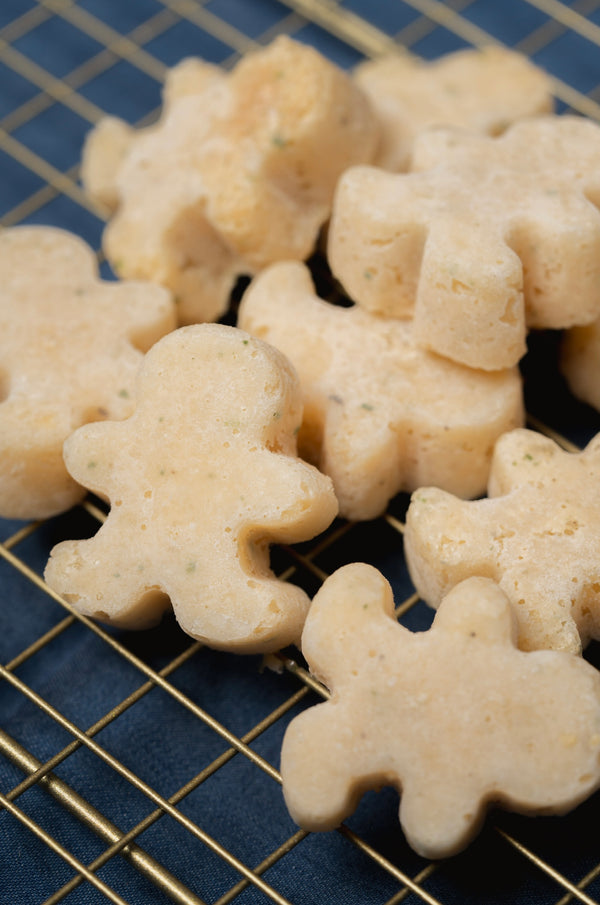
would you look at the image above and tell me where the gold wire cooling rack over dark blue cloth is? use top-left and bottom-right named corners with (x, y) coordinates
top-left (0, 0), bottom-right (600, 905)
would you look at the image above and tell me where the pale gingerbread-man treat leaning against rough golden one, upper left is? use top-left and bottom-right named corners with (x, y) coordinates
top-left (81, 54), bottom-right (244, 323)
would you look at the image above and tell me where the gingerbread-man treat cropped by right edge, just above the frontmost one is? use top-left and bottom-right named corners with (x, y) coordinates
top-left (404, 430), bottom-right (600, 653)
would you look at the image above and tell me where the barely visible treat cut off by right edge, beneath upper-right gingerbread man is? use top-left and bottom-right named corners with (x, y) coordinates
top-left (560, 318), bottom-right (600, 412)
